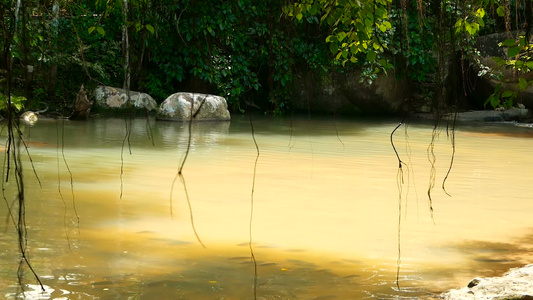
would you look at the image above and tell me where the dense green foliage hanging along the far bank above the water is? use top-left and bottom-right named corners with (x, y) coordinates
top-left (0, 0), bottom-right (532, 112)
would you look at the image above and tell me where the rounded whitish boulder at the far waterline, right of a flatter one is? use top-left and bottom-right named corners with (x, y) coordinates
top-left (156, 93), bottom-right (231, 121)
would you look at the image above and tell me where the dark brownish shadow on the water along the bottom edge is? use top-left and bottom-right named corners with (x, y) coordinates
top-left (1, 241), bottom-right (427, 300)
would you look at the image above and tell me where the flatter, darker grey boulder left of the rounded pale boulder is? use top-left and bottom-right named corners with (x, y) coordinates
top-left (94, 85), bottom-right (157, 111)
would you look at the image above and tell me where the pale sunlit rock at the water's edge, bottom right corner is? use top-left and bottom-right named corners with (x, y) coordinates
top-left (439, 264), bottom-right (533, 300)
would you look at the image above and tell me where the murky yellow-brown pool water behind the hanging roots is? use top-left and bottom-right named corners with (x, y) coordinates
top-left (0, 117), bottom-right (533, 299)
